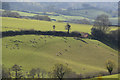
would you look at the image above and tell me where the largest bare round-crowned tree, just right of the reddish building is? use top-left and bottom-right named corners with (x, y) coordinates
top-left (91, 14), bottom-right (111, 39)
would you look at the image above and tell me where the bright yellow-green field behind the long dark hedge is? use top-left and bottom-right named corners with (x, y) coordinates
top-left (2, 17), bottom-right (92, 33)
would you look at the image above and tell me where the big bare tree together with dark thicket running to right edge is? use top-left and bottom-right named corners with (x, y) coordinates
top-left (91, 14), bottom-right (120, 50)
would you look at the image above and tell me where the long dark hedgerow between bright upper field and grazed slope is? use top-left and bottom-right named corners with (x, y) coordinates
top-left (2, 30), bottom-right (89, 38)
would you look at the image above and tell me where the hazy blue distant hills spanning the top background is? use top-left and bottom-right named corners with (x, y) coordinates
top-left (3, 2), bottom-right (118, 25)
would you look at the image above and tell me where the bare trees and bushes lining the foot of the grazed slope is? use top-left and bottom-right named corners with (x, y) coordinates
top-left (2, 60), bottom-right (115, 80)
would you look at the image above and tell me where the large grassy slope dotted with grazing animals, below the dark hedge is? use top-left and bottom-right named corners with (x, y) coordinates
top-left (2, 35), bottom-right (118, 74)
